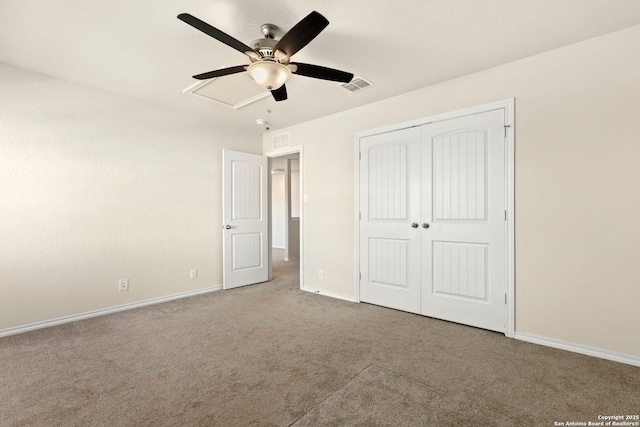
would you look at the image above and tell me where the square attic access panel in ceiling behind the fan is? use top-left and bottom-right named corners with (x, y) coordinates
top-left (182, 73), bottom-right (271, 110)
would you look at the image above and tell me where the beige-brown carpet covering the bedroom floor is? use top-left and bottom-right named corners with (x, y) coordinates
top-left (0, 249), bottom-right (640, 427)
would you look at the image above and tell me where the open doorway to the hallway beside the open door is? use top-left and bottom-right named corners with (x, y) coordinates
top-left (269, 147), bottom-right (303, 288)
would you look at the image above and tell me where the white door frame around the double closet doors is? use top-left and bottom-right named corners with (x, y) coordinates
top-left (354, 98), bottom-right (516, 338)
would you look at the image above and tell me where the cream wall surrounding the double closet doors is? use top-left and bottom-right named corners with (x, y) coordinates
top-left (263, 26), bottom-right (640, 356)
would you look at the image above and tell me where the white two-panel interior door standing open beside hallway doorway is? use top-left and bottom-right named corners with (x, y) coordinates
top-left (222, 150), bottom-right (269, 289)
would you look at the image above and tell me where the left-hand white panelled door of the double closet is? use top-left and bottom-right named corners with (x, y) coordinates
top-left (359, 127), bottom-right (420, 313)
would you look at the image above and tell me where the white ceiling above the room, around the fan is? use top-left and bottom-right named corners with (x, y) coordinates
top-left (0, 0), bottom-right (640, 133)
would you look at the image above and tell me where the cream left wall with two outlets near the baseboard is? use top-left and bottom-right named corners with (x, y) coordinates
top-left (0, 64), bottom-right (261, 331)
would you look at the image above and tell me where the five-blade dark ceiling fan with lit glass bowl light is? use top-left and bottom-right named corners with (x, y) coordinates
top-left (178, 11), bottom-right (353, 101)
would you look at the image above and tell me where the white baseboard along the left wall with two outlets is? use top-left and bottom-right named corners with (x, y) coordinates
top-left (0, 285), bottom-right (222, 338)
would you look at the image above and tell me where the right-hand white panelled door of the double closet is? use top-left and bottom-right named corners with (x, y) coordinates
top-left (420, 110), bottom-right (507, 332)
